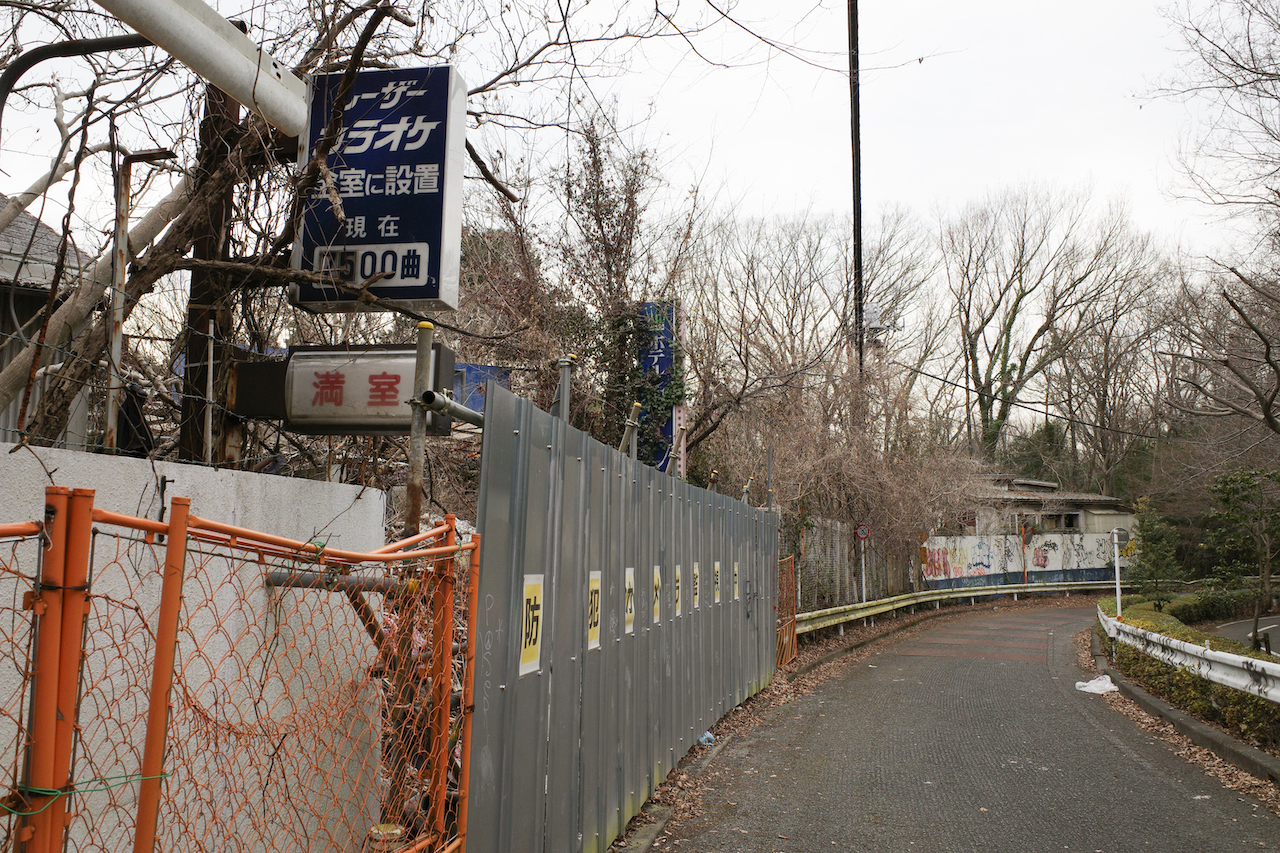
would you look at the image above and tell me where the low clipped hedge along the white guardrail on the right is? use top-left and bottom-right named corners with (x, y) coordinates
top-left (1098, 596), bottom-right (1280, 753)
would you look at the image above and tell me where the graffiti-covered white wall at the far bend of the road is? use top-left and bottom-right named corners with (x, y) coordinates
top-left (923, 533), bottom-right (1135, 588)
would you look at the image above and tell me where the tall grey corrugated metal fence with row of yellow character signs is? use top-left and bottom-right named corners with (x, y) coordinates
top-left (467, 383), bottom-right (778, 853)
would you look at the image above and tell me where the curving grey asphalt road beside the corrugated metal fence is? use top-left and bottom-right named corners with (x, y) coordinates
top-left (660, 608), bottom-right (1280, 853)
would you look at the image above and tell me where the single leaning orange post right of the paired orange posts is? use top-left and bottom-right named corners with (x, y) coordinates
top-left (133, 497), bottom-right (191, 853)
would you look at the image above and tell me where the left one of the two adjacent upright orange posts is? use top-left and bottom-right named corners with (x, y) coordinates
top-left (18, 485), bottom-right (72, 853)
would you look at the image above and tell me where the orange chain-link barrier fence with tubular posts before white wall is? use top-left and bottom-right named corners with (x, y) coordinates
top-left (0, 487), bottom-right (479, 853)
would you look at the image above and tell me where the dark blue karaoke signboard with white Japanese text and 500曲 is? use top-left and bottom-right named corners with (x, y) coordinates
top-left (289, 65), bottom-right (466, 311)
